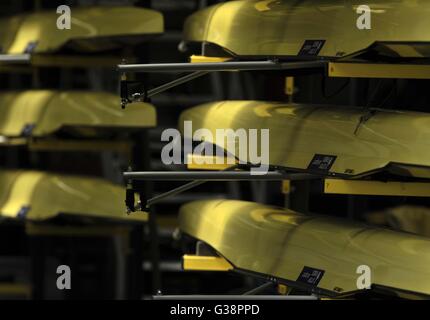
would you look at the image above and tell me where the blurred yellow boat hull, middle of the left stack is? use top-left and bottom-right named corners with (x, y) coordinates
top-left (0, 90), bottom-right (156, 137)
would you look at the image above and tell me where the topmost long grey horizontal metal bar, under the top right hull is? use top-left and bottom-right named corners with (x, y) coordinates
top-left (118, 61), bottom-right (327, 72)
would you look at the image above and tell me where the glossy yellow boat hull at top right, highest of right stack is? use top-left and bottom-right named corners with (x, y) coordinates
top-left (184, 0), bottom-right (430, 58)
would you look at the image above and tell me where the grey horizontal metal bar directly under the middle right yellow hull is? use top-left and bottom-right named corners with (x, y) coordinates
top-left (123, 171), bottom-right (315, 181)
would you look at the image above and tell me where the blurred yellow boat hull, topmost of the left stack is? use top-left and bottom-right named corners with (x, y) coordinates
top-left (0, 6), bottom-right (164, 54)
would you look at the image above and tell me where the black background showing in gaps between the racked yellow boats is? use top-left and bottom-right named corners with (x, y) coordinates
top-left (0, 0), bottom-right (429, 299)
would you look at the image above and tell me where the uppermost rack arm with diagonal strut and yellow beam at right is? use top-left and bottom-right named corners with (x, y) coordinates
top-left (117, 41), bottom-right (430, 108)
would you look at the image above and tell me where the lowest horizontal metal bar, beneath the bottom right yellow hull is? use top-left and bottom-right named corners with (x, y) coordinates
top-left (152, 295), bottom-right (318, 301)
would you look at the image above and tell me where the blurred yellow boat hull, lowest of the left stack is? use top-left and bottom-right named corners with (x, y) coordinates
top-left (0, 170), bottom-right (147, 221)
